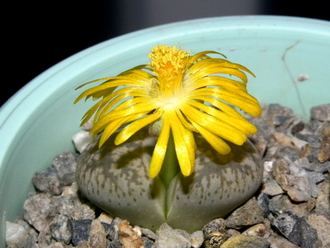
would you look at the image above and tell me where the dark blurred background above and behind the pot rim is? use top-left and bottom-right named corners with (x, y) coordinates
top-left (0, 0), bottom-right (330, 106)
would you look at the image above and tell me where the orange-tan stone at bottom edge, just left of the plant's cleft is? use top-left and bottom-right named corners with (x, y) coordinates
top-left (119, 220), bottom-right (143, 248)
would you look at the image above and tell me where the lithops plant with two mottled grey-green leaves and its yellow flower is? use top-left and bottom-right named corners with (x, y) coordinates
top-left (76, 45), bottom-right (262, 231)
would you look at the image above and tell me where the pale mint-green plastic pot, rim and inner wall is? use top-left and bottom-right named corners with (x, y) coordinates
top-left (0, 16), bottom-right (330, 247)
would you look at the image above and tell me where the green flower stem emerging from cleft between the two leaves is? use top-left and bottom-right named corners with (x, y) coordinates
top-left (159, 133), bottom-right (180, 189)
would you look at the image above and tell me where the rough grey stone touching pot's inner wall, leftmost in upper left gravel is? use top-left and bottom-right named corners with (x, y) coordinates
top-left (32, 168), bottom-right (62, 195)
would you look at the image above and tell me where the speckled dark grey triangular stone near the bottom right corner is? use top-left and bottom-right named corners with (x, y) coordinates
top-left (268, 211), bottom-right (298, 237)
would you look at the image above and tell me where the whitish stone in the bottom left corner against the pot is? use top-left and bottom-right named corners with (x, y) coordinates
top-left (6, 221), bottom-right (29, 247)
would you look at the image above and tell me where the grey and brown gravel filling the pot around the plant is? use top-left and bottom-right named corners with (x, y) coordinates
top-left (7, 104), bottom-right (330, 248)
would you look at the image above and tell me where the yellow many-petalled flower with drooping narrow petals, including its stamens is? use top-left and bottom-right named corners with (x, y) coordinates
top-left (75, 45), bottom-right (261, 178)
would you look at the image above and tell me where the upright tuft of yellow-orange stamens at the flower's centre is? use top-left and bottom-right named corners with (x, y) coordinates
top-left (148, 45), bottom-right (189, 102)
